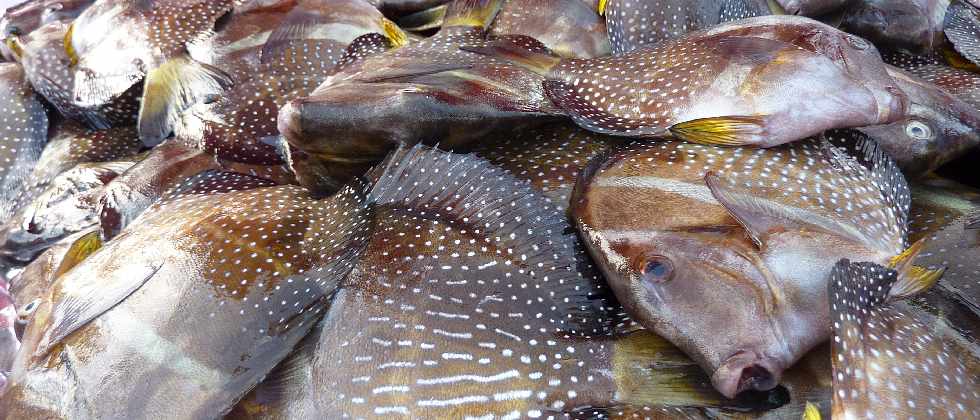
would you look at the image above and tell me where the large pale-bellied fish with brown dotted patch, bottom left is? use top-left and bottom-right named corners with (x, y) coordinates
top-left (0, 171), bottom-right (368, 419)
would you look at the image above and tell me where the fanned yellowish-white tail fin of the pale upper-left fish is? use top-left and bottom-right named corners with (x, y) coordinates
top-left (138, 58), bottom-right (232, 147)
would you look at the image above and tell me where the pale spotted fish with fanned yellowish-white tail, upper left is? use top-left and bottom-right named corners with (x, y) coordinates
top-left (65, 0), bottom-right (234, 146)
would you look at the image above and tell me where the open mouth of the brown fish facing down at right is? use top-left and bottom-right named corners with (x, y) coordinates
top-left (711, 350), bottom-right (782, 399)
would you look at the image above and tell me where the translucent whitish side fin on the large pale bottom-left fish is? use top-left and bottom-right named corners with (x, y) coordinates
top-left (34, 263), bottom-right (163, 357)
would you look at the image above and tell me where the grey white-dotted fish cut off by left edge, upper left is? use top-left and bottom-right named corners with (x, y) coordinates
top-left (0, 63), bottom-right (48, 223)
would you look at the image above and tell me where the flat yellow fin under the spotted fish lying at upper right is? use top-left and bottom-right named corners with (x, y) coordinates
top-left (670, 116), bottom-right (770, 146)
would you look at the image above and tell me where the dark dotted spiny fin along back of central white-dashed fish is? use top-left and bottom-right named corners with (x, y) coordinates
top-left (368, 145), bottom-right (622, 335)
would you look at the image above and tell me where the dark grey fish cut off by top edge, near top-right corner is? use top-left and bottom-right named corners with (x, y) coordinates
top-left (841, 0), bottom-right (950, 54)
